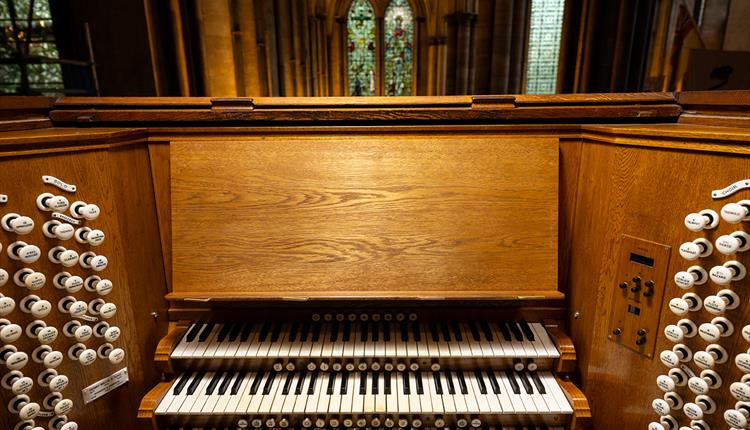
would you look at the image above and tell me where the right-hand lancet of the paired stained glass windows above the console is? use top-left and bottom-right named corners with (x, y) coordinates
top-left (383, 0), bottom-right (414, 96)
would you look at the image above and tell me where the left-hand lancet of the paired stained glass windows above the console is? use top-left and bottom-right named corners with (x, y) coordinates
top-left (346, 0), bottom-right (377, 96)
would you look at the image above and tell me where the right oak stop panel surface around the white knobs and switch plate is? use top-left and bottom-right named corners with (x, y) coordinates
top-left (567, 141), bottom-right (750, 429)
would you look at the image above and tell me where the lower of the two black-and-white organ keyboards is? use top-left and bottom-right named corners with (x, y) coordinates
top-left (155, 370), bottom-right (573, 428)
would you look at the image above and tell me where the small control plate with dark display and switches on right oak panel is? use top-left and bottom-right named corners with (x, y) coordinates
top-left (609, 235), bottom-right (671, 357)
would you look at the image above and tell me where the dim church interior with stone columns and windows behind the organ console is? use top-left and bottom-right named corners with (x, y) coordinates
top-left (0, 0), bottom-right (750, 97)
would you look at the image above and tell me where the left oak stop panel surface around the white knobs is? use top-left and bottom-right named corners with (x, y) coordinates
top-left (0, 137), bottom-right (166, 428)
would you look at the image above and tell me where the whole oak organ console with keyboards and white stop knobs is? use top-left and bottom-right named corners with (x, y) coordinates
top-left (0, 92), bottom-right (750, 430)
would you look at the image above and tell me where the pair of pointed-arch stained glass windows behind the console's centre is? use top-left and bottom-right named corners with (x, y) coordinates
top-left (346, 0), bottom-right (415, 96)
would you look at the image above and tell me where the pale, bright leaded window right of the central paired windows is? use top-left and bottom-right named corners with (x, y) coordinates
top-left (526, 0), bottom-right (565, 94)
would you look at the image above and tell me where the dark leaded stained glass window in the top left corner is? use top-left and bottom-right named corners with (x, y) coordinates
top-left (0, 0), bottom-right (63, 94)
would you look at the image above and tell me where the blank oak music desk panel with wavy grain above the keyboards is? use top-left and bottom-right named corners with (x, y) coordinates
top-left (171, 135), bottom-right (557, 297)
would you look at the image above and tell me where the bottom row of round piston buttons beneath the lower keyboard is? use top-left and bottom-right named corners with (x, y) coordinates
top-left (242, 416), bottom-right (482, 429)
